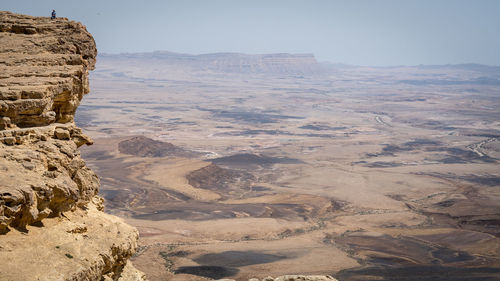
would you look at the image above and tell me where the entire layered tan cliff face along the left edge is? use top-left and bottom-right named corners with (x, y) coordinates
top-left (0, 12), bottom-right (144, 280)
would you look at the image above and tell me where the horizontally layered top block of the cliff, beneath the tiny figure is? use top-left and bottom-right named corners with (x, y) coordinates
top-left (0, 12), bottom-right (97, 130)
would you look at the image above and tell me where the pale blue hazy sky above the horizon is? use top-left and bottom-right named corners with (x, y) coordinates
top-left (0, 0), bottom-right (500, 65)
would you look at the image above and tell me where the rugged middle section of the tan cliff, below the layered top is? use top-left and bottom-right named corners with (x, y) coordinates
top-left (0, 122), bottom-right (99, 232)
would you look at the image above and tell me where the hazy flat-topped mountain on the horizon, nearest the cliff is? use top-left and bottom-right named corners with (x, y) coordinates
top-left (99, 51), bottom-right (324, 75)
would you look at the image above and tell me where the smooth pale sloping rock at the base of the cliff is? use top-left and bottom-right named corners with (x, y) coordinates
top-left (0, 200), bottom-right (141, 281)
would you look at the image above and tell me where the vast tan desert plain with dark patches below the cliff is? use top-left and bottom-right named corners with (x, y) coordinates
top-left (75, 52), bottom-right (500, 281)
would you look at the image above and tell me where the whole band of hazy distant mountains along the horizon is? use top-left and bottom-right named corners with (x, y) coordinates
top-left (97, 51), bottom-right (500, 80)
